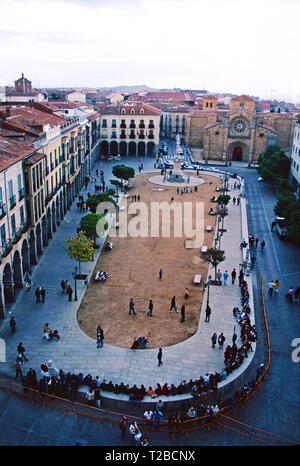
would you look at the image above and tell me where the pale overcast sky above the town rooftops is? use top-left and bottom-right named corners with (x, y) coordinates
top-left (0, 0), bottom-right (300, 101)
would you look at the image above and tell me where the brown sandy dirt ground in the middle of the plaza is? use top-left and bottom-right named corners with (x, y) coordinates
top-left (77, 174), bottom-right (222, 348)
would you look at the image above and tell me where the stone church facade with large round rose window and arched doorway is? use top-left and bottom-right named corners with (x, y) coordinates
top-left (186, 95), bottom-right (296, 162)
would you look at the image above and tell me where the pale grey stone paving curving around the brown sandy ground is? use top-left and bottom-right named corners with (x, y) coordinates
top-left (0, 171), bottom-right (254, 394)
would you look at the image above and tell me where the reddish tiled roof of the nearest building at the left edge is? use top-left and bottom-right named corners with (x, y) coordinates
top-left (0, 136), bottom-right (34, 171)
